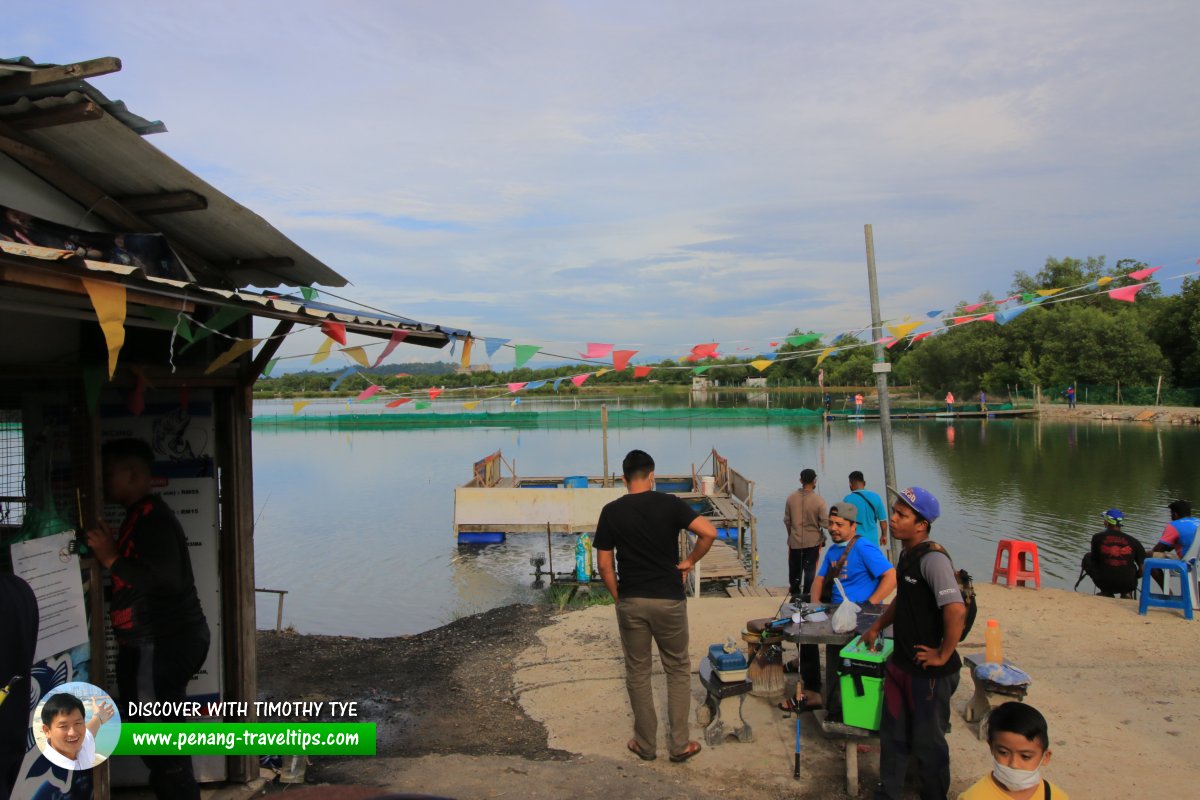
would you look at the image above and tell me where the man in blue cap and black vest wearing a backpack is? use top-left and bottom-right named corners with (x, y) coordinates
top-left (863, 486), bottom-right (967, 800)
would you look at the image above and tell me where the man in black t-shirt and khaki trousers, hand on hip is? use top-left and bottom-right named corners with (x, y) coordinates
top-left (594, 450), bottom-right (716, 762)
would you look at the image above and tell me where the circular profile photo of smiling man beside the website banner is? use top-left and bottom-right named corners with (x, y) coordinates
top-left (31, 681), bottom-right (121, 770)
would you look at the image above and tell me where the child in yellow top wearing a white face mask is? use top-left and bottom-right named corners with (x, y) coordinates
top-left (959, 702), bottom-right (1069, 800)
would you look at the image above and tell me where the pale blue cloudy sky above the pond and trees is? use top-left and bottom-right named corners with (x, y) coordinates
top-left (4, 0), bottom-right (1200, 366)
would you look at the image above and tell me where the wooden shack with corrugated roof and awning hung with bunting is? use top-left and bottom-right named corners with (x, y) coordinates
top-left (0, 58), bottom-right (468, 799)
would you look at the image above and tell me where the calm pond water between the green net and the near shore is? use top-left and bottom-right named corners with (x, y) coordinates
top-left (254, 410), bottom-right (1200, 636)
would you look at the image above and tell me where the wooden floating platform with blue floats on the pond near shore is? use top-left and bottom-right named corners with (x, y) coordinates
top-left (454, 450), bottom-right (758, 591)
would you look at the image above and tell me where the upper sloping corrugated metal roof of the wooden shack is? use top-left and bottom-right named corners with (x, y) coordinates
top-left (0, 59), bottom-right (347, 287)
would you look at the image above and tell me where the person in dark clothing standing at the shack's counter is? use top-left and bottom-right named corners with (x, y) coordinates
top-left (88, 439), bottom-right (209, 800)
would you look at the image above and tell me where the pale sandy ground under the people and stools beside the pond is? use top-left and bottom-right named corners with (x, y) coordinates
top-left (515, 585), bottom-right (1200, 799)
